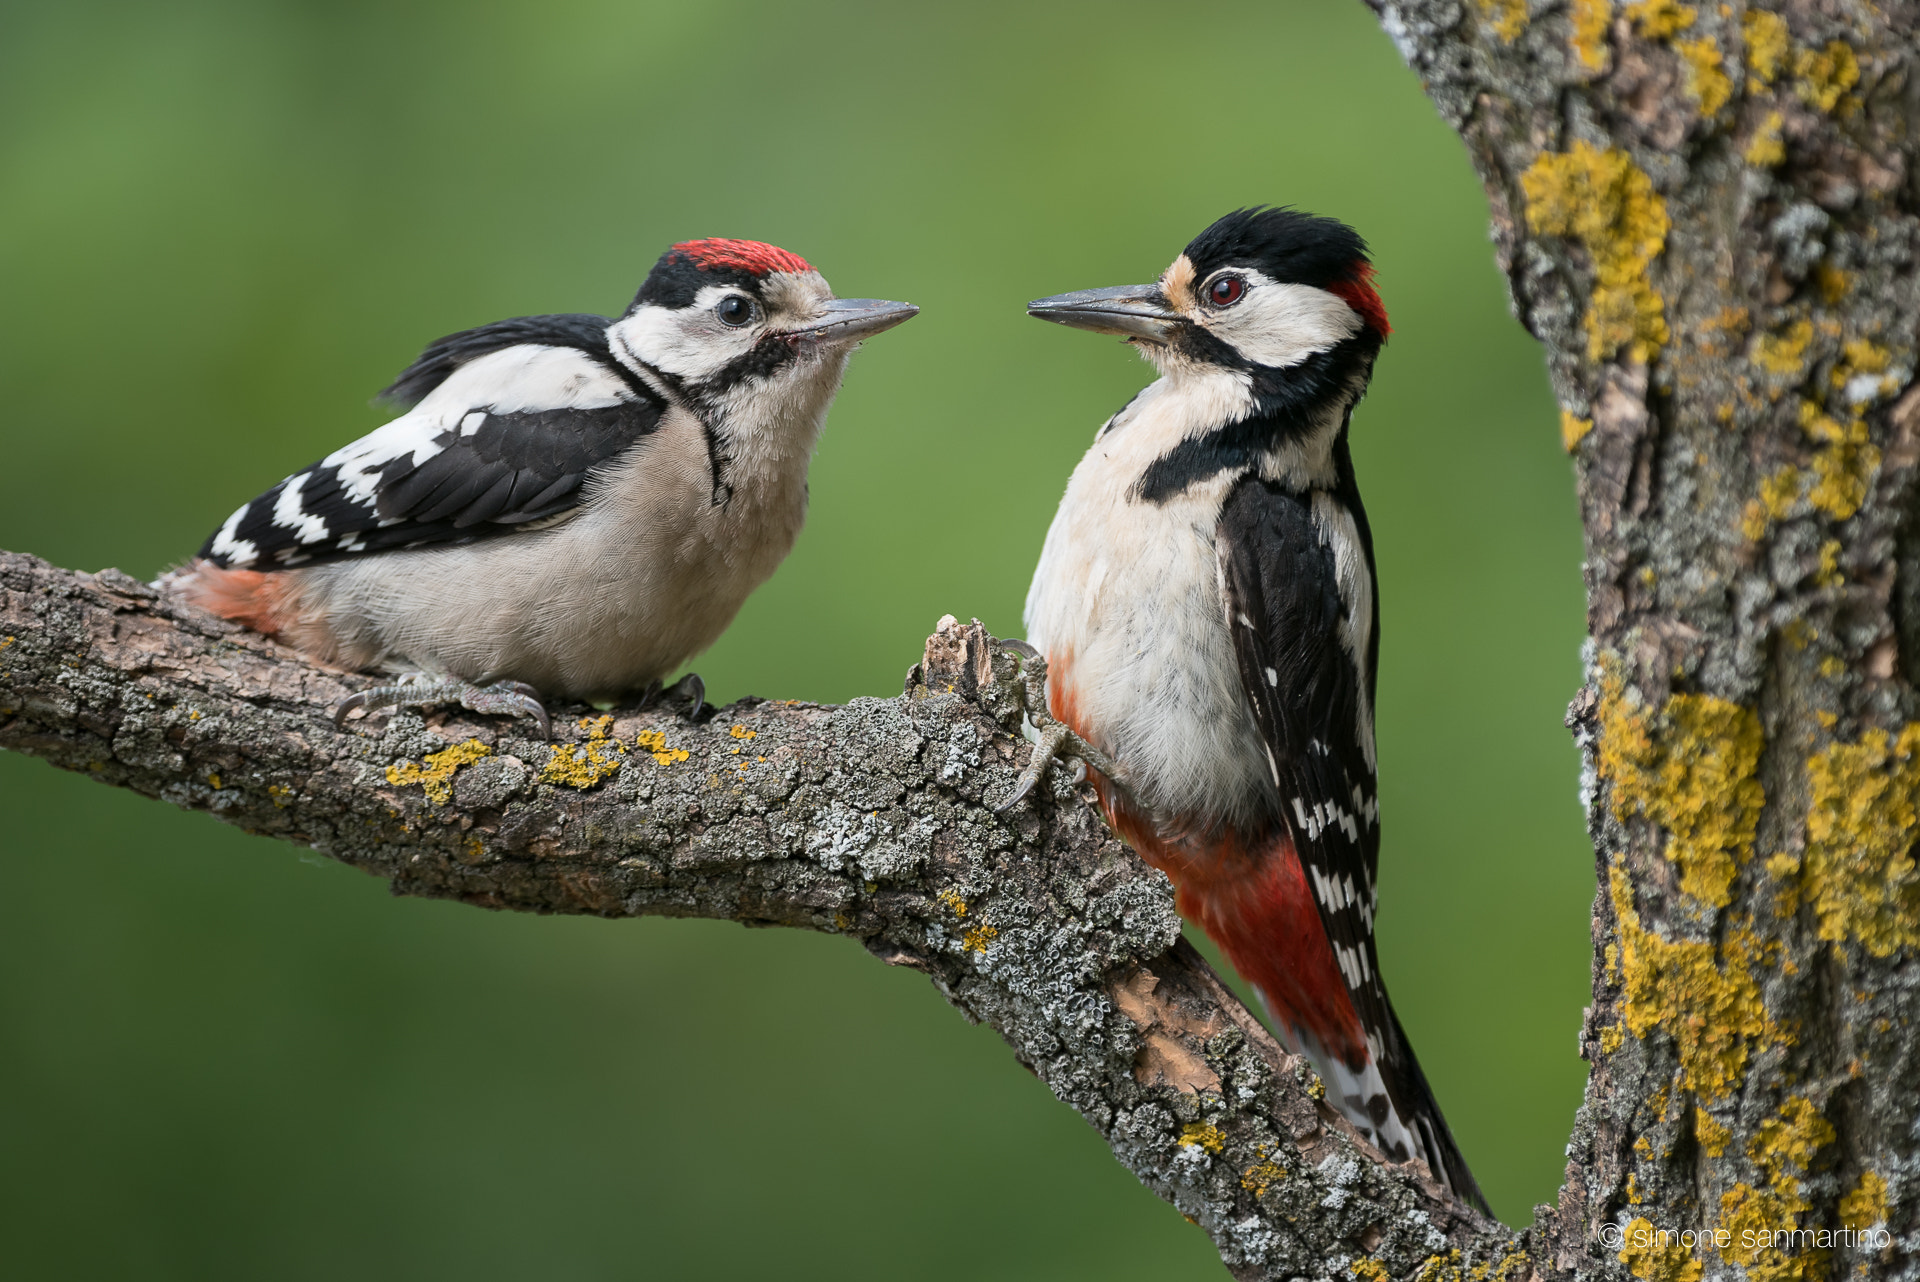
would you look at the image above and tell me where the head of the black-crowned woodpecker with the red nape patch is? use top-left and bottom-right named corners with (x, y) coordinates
top-left (1027, 207), bottom-right (1390, 374)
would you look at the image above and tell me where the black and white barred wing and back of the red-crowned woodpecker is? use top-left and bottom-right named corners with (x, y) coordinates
top-left (200, 317), bottom-right (666, 570)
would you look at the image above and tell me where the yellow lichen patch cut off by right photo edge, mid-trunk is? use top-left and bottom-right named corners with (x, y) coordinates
top-left (1801, 724), bottom-right (1920, 958)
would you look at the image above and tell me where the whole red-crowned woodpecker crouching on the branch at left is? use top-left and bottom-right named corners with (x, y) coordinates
top-left (163, 240), bottom-right (920, 731)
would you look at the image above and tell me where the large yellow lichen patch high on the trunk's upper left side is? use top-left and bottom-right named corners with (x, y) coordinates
top-left (1521, 142), bottom-right (1668, 361)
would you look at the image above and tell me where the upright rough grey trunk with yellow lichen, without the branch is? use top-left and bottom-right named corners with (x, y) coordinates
top-left (1369, 0), bottom-right (1920, 1282)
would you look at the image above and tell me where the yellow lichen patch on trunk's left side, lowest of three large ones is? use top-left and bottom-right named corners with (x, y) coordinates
top-left (1609, 864), bottom-right (1789, 1104)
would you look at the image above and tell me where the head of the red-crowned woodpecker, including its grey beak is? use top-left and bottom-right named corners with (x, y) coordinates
top-left (607, 240), bottom-right (920, 433)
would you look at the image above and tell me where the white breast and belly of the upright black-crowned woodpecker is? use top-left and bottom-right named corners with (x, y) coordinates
top-left (1027, 374), bottom-right (1277, 823)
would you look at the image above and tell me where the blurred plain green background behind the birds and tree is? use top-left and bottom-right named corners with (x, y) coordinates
top-left (0, 0), bottom-right (1592, 1280)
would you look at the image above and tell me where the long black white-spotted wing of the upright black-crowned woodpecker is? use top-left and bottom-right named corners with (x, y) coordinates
top-left (1215, 477), bottom-right (1484, 1209)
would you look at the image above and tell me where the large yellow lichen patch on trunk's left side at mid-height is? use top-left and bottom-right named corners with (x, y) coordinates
top-left (1599, 668), bottom-right (1766, 908)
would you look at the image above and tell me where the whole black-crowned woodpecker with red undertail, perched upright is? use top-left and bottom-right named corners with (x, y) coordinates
top-left (1016, 209), bottom-right (1486, 1209)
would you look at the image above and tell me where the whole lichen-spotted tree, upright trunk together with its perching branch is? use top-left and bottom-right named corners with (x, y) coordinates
top-left (0, 0), bottom-right (1920, 1282)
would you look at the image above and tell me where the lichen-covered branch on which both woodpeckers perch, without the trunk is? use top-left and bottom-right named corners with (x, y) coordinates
top-left (0, 553), bottom-right (1519, 1280)
